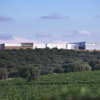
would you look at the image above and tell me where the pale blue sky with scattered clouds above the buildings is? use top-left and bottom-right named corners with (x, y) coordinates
top-left (0, 0), bottom-right (100, 44)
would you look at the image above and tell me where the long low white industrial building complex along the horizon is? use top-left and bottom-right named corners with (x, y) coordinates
top-left (0, 42), bottom-right (100, 50)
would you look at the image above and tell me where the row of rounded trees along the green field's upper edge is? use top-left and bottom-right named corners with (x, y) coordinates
top-left (0, 60), bottom-right (100, 82)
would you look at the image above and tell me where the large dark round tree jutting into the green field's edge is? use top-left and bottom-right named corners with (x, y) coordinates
top-left (19, 67), bottom-right (40, 82)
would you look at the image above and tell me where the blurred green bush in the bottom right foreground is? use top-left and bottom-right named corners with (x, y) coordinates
top-left (39, 88), bottom-right (100, 100)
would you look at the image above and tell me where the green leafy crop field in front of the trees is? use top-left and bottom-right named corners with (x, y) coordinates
top-left (0, 70), bottom-right (100, 100)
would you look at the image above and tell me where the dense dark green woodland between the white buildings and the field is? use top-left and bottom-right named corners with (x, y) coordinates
top-left (0, 48), bottom-right (100, 78)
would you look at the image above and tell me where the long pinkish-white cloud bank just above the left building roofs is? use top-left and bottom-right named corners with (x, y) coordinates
top-left (0, 37), bottom-right (41, 44)
